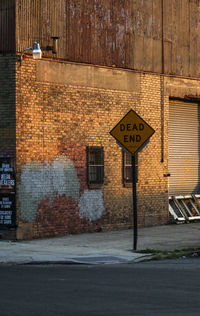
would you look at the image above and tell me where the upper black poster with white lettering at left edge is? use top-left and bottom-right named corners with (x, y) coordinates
top-left (0, 157), bottom-right (15, 191)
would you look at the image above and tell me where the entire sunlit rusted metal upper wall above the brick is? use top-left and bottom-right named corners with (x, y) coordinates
top-left (16, 0), bottom-right (200, 76)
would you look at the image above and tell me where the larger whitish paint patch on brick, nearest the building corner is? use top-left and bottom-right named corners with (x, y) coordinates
top-left (19, 156), bottom-right (80, 223)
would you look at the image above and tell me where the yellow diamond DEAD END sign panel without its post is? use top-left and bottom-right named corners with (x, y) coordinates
top-left (110, 110), bottom-right (155, 155)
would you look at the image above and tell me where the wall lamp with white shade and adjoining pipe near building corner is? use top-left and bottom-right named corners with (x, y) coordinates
top-left (19, 36), bottom-right (59, 63)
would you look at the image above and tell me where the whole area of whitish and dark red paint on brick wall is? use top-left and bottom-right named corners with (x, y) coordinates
top-left (19, 156), bottom-right (104, 231)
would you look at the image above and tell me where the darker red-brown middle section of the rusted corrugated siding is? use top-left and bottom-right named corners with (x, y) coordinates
top-left (66, 0), bottom-right (131, 68)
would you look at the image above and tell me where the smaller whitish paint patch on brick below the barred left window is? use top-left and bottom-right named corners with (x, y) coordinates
top-left (78, 190), bottom-right (104, 221)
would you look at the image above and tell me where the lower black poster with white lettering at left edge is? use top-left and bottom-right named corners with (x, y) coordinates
top-left (0, 193), bottom-right (16, 227)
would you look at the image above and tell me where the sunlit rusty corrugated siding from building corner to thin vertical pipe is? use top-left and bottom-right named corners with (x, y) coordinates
top-left (17, 0), bottom-right (162, 67)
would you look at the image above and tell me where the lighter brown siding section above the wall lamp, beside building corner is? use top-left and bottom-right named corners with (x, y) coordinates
top-left (16, 0), bottom-right (67, 58)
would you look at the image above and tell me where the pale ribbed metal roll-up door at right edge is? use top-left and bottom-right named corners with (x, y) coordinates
top-left (169, 101), bottom-right (200, 195)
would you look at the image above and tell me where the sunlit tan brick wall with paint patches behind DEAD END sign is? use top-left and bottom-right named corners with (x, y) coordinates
top-left (16, 58), bottom-right (168, 238)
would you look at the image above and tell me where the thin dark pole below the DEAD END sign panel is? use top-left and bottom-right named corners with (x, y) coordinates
top-left (132, 155), bottom-right (138, 250)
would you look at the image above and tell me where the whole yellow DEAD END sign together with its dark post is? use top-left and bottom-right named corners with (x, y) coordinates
top-left (110, 110), bottom-right (155, 250)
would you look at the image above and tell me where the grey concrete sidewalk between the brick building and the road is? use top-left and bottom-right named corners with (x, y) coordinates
top-left (0, 223), bottom-right (200, 264)
